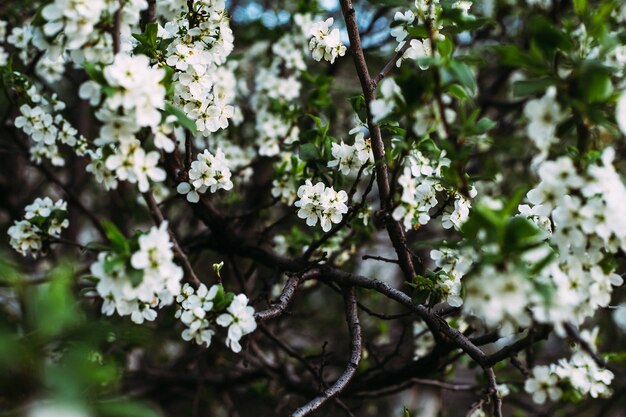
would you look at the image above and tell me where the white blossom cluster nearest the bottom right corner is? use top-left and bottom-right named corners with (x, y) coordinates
top-left (524, 338), bottom-right (614, 404)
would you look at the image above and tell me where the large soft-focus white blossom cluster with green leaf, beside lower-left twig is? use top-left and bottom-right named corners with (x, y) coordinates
top-left (91, 222), bottom-right (183, 324)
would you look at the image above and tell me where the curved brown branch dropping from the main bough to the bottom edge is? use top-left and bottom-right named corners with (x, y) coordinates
top-left (291, 287), bottom-right (362, 417)
